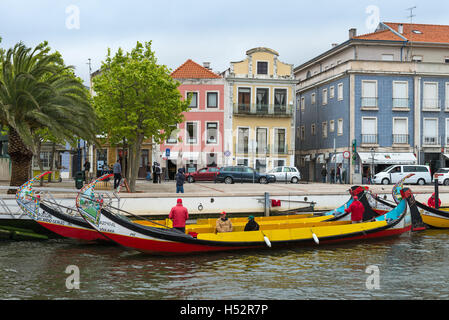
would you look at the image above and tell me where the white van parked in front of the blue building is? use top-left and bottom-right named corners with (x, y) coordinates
top-left (373, 164), bottom-right (432, 185)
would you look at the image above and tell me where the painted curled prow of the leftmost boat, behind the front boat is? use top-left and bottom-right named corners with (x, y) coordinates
top-left (16, 171), bottom-right (110, 242)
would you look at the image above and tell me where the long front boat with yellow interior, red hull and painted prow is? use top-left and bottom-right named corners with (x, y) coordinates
top-left (76, 178), bottom-right (415, 254)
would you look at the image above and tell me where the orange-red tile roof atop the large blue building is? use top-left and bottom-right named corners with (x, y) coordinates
top-left (354, 22), bottom-right (449, 43)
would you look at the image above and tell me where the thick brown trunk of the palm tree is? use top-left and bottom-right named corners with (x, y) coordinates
top-left (8, 126), bottom-right (33, 194)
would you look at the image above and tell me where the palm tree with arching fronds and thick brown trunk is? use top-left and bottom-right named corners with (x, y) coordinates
top-left (0, 42), bottom-right (96, 191)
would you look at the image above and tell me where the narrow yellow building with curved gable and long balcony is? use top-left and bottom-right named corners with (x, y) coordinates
top-left (224, 47), bottom-right (296, 172)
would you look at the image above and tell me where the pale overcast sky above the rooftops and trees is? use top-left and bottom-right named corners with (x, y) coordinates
top-left (0, 0), bottom-right (449, 84)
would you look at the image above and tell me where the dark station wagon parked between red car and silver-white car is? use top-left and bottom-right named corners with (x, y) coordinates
top-left (216, 166), bottom-right (276, 184)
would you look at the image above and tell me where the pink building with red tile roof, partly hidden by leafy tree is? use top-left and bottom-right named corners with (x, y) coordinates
top-left (159, 59), bottom-right (225, 179)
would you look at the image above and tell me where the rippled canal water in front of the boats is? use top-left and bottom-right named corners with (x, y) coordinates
top-left (0, 230), bottom-right (449, 300)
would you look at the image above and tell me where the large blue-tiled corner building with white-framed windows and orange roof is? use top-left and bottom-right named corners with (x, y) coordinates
top-left (294, 23), bottom-right (449, 183)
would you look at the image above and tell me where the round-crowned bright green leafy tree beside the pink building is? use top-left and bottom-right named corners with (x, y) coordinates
top-left (93, 42), bottom-right (190, 192)
